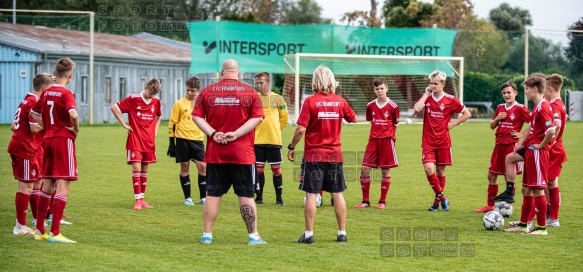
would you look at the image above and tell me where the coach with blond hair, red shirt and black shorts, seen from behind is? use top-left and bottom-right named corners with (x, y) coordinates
top-left (287, 66), bottom-right (356, 244)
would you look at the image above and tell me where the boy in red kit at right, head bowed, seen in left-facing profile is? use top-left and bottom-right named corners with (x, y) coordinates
top-left (505, 75), bottom-right (555, 235)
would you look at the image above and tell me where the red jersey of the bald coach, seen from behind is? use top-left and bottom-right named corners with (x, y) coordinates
top-left (192, 79), bottom-right (265, 164)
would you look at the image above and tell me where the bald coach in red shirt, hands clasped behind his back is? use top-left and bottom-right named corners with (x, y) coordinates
top-left (192, 60), bottom-right (267, 245)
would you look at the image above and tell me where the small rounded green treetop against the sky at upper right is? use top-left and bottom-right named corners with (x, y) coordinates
top-left (490, 3), bottom-right (532, 31)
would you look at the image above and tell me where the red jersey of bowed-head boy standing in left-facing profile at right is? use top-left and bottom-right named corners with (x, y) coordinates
top-left (523, 99), bottom-right (555, 150)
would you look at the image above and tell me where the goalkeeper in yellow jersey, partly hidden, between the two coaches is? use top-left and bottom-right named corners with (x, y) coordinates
top-left (255, 72), bottom-right (288, 206)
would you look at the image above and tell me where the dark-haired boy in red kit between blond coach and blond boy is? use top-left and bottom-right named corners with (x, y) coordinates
top-left (354, 77), bottom-right (399, 209)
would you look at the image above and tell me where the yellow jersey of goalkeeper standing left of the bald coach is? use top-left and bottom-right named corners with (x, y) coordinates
top-left (168, 97), bottom-right (204, 141)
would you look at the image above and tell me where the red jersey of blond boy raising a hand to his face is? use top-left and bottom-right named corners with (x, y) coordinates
top-left (421, 93), bottom-right (466, 149)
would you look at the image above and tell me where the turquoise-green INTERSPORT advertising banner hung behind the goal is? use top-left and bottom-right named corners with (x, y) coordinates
top-left (188, 21), bottom-right (456, 74)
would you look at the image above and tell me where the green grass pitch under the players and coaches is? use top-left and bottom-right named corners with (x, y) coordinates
top-left (0, 122), bottom-right (583, 271)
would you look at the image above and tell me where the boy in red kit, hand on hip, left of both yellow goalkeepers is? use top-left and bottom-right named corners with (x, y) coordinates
top-left (111, 78), bottom-right (162, 210)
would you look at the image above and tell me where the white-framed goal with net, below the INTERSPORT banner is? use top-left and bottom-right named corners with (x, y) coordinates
top-left (282, 53), bottom-right (464, 123)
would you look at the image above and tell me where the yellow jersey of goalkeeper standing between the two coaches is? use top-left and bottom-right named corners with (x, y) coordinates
top-left (255, 92), bottom-right (289, 146)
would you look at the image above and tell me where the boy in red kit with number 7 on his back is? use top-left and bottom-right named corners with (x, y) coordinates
top-left (30, 58), bottom-right (79, 243)
